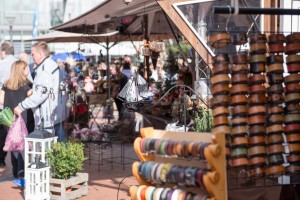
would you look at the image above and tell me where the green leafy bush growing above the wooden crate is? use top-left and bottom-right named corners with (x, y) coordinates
top-left (46, 142), bottom-right (87, 179)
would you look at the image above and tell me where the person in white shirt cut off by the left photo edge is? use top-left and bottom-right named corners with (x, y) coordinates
top-left (0, 41), bottom-right (17, 167)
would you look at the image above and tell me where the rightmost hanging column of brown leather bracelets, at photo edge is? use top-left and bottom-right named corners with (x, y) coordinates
top-left (284, 33), bottom-right (300, 173)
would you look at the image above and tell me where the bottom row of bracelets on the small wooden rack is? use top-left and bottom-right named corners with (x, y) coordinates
top-left (130, 185), bottom-right (208, 200)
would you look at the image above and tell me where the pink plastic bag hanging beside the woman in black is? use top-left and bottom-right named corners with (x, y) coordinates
top-left (3, 115), bottom-right (28, 151)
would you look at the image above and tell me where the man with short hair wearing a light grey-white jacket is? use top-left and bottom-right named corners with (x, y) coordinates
top-left (14, 42), bottom-right (66, 141)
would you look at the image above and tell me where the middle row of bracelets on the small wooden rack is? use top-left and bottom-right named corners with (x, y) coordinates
top-left (138, 161), bottom-right (208, 188)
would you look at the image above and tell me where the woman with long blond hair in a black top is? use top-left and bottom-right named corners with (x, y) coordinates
top-left (0, 60), bottom-right (34, 179)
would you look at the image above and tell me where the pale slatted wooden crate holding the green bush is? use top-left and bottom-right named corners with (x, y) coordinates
top-left (50, 173), bottom-right (89, 200)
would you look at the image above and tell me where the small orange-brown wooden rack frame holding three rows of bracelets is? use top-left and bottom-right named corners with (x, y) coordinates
top-left (130, 127), bottom-right (227, 200)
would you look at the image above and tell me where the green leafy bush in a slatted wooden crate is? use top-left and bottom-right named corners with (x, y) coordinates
top-left (46, 142), bottom-right (88, 199)
